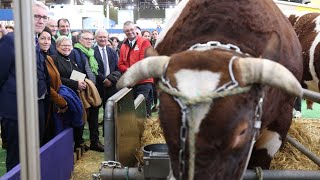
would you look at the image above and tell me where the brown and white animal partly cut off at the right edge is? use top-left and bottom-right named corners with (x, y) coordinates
top-left (289, 13), bottom-right (320, 109)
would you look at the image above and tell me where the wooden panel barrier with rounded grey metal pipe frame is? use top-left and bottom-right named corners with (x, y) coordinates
top-left (104, 88), bottom-right (146, 166)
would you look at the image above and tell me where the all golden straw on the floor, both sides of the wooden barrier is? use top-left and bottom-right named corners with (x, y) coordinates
top-left (71, 119), bottom-right (320, 180)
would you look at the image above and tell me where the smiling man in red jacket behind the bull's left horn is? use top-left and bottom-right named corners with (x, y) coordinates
top-left (118, 21), bottom-right (153, 117)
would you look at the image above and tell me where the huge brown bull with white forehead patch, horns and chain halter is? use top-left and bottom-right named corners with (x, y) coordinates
top-left (117, 0), bottom-right (302, 180)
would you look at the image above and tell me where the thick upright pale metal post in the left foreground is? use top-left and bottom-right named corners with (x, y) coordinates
top-left (14, 0), bottom-right (41, 180)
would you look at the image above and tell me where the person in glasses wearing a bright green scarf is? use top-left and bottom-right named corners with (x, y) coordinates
top-left (74, 30), bottom-right (104, 152)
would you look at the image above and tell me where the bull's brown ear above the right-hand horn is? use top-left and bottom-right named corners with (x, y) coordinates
top-left (261, 32), bottom-right (281, 62)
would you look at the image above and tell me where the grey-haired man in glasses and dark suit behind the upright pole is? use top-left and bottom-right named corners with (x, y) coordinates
top-left (0, 1), bottom-right (49, 171)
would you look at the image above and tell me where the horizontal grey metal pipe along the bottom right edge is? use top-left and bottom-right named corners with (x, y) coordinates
top-left (244, 170), bottom-right (320, 180)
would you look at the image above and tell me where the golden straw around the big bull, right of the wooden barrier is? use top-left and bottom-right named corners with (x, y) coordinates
top-left (136, 119), bottom-right (320, 170)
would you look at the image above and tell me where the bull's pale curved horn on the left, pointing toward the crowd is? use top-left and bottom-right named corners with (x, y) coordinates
top-left (117, 56), bottom-right (170, 89)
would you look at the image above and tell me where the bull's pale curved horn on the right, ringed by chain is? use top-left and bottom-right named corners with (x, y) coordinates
top-left (236, 58), bottom-right (303, 97)
